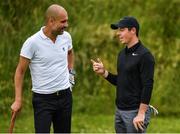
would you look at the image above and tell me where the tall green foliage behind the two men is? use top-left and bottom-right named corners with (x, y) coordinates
top-left (0, 0), bottom-right (180, 116)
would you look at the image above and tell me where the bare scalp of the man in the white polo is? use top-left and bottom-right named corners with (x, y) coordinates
top-left (45, 4), bottom-right (67, 23)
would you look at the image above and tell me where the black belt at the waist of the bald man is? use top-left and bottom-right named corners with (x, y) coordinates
top-left (33, 88), bottom-right (71, 97)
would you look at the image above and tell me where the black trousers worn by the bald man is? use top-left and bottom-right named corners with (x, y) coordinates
top-left (32, 88), bottom-right (72, 133)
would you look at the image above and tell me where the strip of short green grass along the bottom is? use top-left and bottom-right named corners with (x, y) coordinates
top-left (0, 113), bottom-right (180, 133)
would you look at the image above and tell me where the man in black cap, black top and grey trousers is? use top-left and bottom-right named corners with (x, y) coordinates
top-left (91, 17), bottom-right (155, 133)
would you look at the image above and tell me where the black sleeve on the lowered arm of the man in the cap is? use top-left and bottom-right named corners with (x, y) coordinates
top-left (140, 53), bottom-right (155, 104)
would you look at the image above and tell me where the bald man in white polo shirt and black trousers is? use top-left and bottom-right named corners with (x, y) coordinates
top-left (11, 4), bottom-right (74, 133)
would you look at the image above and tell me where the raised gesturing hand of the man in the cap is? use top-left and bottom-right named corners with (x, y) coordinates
top-left (91, 58), bottom-right (106, 76)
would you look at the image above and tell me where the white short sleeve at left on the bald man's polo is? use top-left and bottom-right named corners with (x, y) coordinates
top-left (20, 38), bottom-right (35, 59)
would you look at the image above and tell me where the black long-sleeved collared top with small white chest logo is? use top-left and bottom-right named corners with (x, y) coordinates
top-left (106, 41), bottom-right (155, 110)
